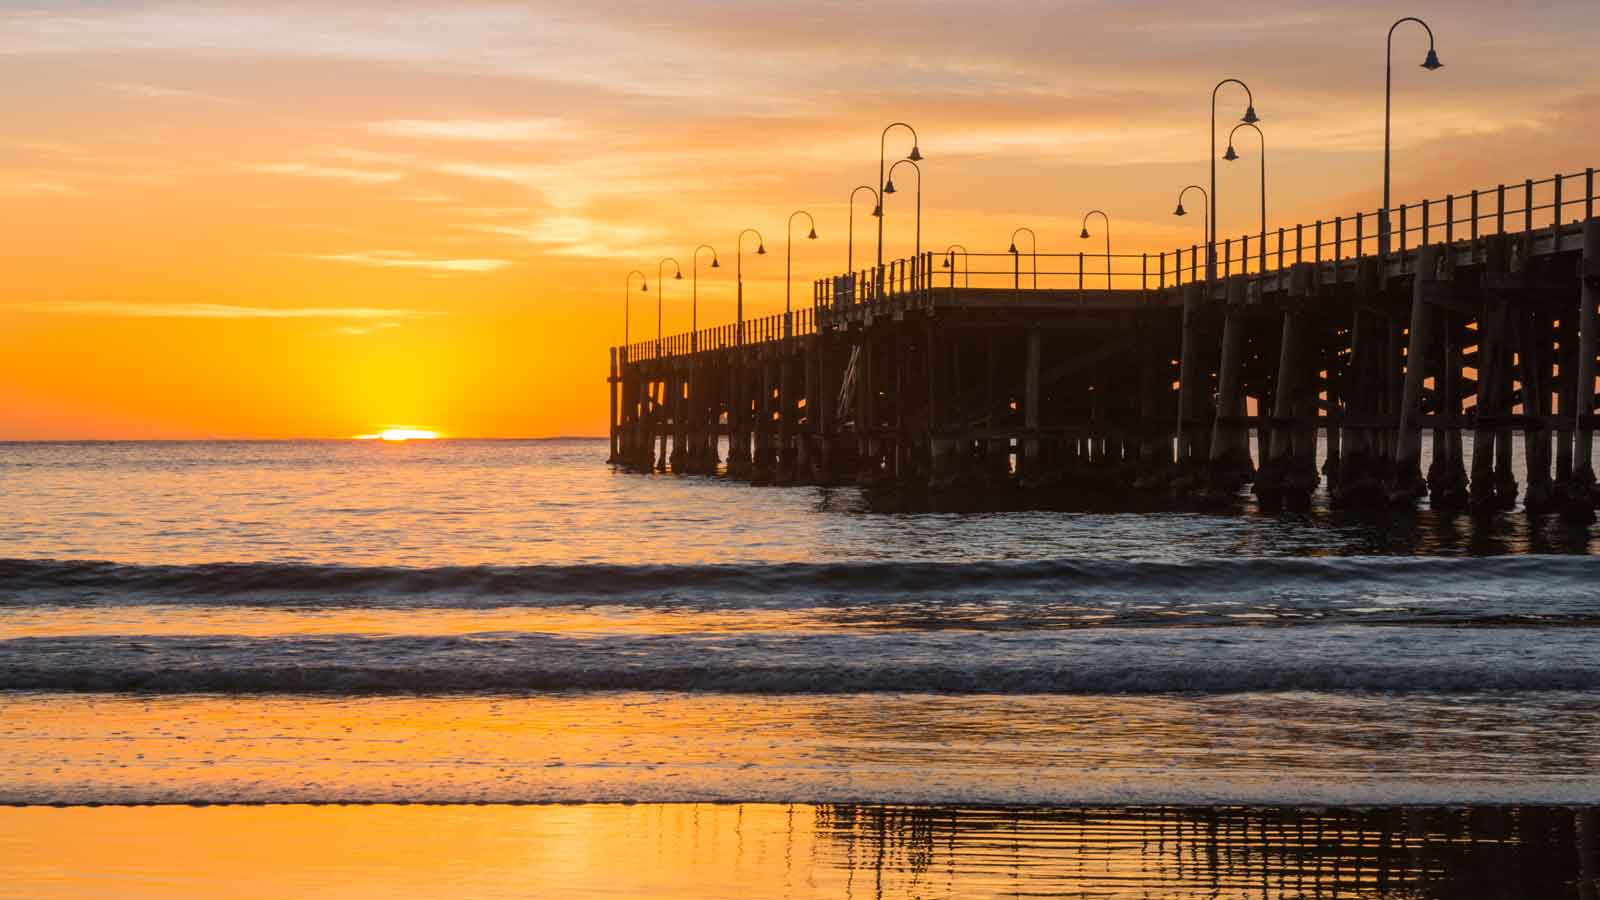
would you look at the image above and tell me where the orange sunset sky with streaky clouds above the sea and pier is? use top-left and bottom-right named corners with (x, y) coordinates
top-left (0, 0), bottom-right (1600, 439)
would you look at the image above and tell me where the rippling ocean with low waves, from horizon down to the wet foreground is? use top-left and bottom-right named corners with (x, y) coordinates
top-left (0, 439), bottom-right (1600, 897)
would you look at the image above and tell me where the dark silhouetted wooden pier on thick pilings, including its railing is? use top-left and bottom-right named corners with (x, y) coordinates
top-left (611, 168), bottom-right (1600, 519)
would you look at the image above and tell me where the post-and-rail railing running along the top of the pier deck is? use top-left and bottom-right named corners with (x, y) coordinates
top-left (622, 168), bottom-right (1597, 362)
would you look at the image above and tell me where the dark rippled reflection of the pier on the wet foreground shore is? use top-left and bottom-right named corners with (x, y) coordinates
top-left (816, 806), bottom-right (1600, 900)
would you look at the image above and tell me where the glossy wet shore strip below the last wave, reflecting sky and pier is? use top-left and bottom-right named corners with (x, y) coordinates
top-left (0, 804), bottom-right (1600, 900)
